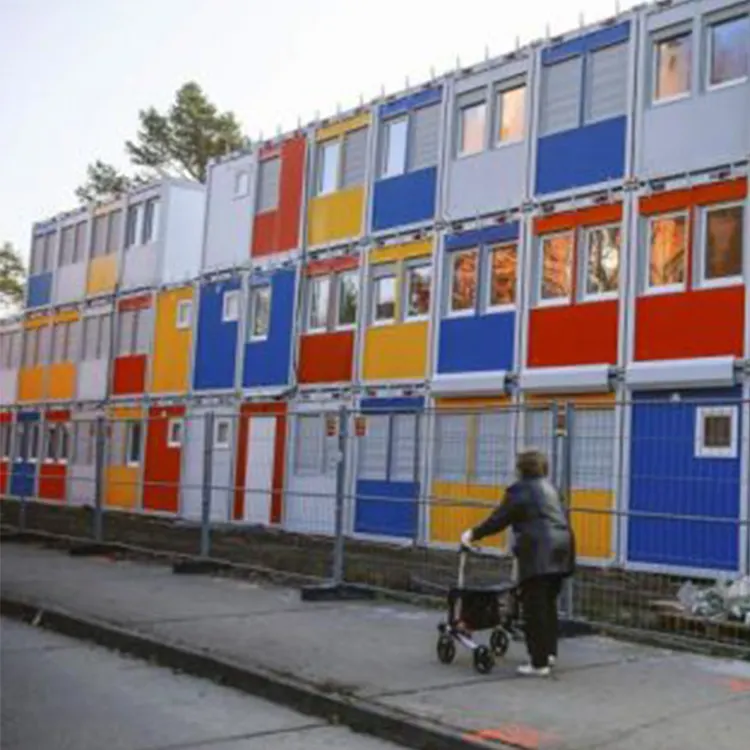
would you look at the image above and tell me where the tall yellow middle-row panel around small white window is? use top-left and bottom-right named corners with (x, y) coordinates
top-left (151, 288), bottom-right (193, 393)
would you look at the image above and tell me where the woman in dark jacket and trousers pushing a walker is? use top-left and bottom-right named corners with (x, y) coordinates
top-left (461, 450), bottom-right (575, 677)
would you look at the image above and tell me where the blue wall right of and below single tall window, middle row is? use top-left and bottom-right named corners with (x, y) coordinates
top-left (242, 270), bottom-right (295, 388)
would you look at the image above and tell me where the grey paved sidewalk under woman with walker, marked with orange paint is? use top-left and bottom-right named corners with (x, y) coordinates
top-left (1, 543), bottom-right (750, 750)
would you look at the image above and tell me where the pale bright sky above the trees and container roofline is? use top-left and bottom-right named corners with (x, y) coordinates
top-left (0, 0), bottom-right (634, 259)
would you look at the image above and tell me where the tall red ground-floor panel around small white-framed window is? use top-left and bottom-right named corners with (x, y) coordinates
top-left (143, 406), bottom-right (185, 513)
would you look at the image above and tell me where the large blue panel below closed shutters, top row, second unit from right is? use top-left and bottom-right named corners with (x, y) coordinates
top-left (536, 117), bottom-right (627, 194)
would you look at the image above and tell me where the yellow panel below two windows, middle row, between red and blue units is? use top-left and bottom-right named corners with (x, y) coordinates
top-left (362, 321), bottom-right (428, 380)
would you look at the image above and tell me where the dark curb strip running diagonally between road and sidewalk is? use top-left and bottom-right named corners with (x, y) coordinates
top-left (0, 594), bottom-right (502, 750)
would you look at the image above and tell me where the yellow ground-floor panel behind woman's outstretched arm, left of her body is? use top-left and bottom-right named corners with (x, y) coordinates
top-left (430, 482), bottom-right (508, 550)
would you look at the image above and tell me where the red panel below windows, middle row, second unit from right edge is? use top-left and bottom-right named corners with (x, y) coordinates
top-left (528, 300), bottom-right (618, 367)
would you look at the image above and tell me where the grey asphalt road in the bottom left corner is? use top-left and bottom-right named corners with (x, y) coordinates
top-left (0, 618), bottom-right (395, 750)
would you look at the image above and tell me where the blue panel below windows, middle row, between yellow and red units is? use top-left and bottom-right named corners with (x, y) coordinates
top-left (437, 312), bottom-right (516, 374)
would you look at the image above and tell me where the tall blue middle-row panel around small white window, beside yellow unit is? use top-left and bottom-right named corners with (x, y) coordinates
top-left (193, 278), bottom-right (240, 391)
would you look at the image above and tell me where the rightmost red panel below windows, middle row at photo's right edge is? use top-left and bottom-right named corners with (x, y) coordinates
top-left (635, 286), bottom-right (745, 361)
